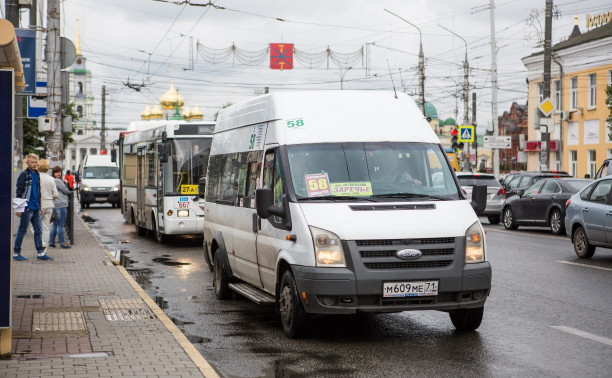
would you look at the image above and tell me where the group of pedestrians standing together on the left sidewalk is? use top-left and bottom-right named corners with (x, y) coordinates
top-left (13, 154), bottom-right (74, 261)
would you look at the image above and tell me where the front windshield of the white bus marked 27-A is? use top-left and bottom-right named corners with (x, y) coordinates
top-left (164, 138), bottom-right (212, 195)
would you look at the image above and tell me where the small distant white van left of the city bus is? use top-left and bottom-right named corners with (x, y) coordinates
top-left (77, 155), bottom-right (119, 209)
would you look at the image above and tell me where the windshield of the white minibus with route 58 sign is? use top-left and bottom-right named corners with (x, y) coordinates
top-left (287, 142), bottom-right (460, 200)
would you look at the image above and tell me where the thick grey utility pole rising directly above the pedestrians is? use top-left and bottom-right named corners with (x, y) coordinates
top-left (46, 0), bottom-right (63, 167)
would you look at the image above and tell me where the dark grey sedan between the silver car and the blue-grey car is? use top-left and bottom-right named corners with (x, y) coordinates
top-left (502, 177), bottom-right (593, 235)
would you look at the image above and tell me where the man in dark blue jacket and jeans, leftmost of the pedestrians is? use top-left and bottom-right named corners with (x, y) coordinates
top-left (13, 154), bottom-right (53, 261)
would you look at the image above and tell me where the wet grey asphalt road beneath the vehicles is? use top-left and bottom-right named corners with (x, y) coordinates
top-left (85, 206), bottom-right (612, 377)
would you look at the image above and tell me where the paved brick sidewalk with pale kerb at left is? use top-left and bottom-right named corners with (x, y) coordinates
top-left (0, 212), bottom-right (218, 377)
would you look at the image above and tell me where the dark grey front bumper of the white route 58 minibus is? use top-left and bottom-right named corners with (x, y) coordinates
top-left (292, 262), bottom-right (491, 314)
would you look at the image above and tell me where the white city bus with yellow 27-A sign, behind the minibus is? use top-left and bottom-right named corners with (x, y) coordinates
top-left (117, 121), bottom-right (215, 244)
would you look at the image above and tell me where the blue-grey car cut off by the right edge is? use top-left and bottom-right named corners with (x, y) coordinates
top-left (565, 176), bottom-right (612, 259)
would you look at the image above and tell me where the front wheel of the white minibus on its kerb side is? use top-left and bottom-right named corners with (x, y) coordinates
top-left (278, 270), bottom-right (310, 339)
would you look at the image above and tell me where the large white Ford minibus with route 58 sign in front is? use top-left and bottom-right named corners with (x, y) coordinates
top-left (204, 91), bottom-right (491, 337)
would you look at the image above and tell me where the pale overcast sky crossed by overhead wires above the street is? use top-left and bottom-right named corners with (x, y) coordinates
top-left (2, 0), bottom-right (612, 130)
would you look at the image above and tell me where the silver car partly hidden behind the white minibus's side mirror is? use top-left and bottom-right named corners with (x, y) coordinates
top-left (457, 172), bottom-right (506, 224)
